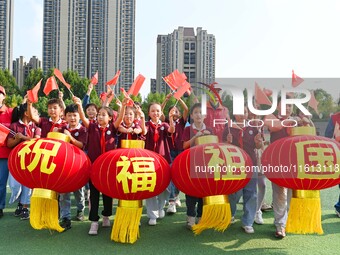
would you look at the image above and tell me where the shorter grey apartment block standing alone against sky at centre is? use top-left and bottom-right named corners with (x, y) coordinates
top-left (156, 27), bottom-right (215, 93)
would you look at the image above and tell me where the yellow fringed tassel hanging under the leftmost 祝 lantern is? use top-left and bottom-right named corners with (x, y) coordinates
top-left (30, 188), bottom-right (64, 232)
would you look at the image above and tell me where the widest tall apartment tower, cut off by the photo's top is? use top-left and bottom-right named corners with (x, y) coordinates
top-left (43, 0), bottom-right (136, 91)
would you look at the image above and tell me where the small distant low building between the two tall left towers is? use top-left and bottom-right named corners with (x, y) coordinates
top-left (13, 56), bottom-right (41, 88)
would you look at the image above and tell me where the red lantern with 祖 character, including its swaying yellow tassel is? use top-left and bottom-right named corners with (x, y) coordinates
top-left (171, 136), bottom-right (252, 234)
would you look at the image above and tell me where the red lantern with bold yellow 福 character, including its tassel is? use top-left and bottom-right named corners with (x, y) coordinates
top-left (91, 140), bottom-right (171, 243)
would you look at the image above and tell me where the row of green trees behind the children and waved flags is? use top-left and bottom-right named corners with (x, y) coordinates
top-left (0, 69), bottom-right (340, 120)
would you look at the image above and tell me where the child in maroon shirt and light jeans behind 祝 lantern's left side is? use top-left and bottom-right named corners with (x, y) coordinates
top-left (7, 103), bottom-right (41, 220)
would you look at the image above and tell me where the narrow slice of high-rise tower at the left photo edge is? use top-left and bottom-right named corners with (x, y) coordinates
top-left (0, 0), bottom-right (14, 71)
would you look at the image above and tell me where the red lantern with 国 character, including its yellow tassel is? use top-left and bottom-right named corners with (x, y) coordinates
top-left (262, 127), bottom-right (340, 234)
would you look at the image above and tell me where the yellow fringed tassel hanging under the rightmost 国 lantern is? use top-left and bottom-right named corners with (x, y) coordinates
top-left (286, 190), bottom-right (323, 235)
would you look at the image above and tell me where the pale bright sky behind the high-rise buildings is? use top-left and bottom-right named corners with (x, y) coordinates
top-left (13, 0), bottom-right (340, 95)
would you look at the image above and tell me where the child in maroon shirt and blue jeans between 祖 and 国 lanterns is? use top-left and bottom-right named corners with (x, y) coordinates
top-left (223, 107), bottom-right (263, 234)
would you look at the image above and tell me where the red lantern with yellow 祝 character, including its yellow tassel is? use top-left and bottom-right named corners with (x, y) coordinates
top-left (8, 132), bottom-right (91, 232)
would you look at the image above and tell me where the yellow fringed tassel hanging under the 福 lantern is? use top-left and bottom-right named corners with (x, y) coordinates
top-left (111, 200), bottom-right (143, 244)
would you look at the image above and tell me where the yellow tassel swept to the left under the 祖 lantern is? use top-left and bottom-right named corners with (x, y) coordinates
top-left (192, 195), bottom-right (231, 235)
